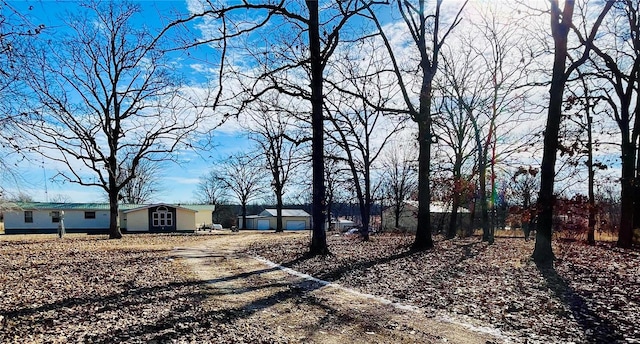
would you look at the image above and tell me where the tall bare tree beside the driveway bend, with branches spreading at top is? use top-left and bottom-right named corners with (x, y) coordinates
top-left (182, 0), bottom-right (384, 254)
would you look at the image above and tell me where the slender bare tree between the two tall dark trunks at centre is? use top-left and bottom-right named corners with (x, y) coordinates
top-left (325, 45), bottom-right (405, 241)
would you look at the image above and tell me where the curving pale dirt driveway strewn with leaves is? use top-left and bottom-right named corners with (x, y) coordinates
top-left (175, 232), bottom-right (505, 344)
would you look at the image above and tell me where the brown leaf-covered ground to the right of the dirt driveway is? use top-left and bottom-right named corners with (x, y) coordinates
top-left (251, 235), bottom-right (640, 343)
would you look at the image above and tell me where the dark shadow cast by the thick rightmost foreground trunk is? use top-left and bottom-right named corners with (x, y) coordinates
top-left (537, 265), bottom-right (624, 343)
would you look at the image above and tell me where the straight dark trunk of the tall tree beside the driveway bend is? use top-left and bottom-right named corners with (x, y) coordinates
top-left (305, 0), bottom-right (329, 255)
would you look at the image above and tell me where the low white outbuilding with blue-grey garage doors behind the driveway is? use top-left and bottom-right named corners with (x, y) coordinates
top-left (238, 209), bottom-right (311, 230)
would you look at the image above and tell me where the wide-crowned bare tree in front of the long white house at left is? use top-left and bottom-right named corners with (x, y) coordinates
top-left (16, 2), bottom-right (224, 238)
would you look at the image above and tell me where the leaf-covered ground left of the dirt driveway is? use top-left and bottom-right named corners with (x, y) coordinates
top-left (0, 235), bottom-right (288, 343)
